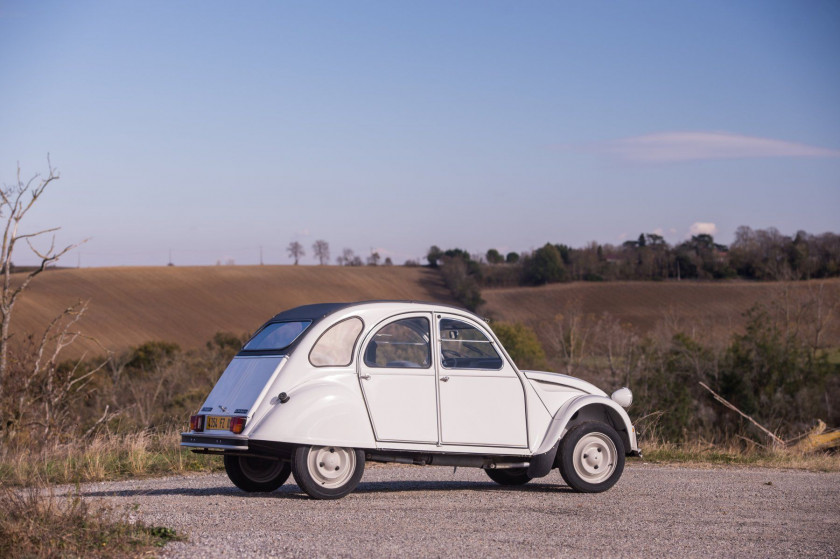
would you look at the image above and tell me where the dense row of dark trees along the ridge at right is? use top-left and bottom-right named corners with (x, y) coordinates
top-left (426, 226), bottom-right (840, 310)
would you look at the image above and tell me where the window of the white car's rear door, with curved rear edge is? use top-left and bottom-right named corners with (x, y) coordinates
top-left (365, 317), bottom-right (432, 369)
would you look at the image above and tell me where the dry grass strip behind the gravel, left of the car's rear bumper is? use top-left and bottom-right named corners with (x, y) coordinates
top-left (0, 430), bottom-right (222, 485)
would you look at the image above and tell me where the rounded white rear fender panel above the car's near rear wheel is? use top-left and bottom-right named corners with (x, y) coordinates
top-left (248, 373), bottom-right (376, 448)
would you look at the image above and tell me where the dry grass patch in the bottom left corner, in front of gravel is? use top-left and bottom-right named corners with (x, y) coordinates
top-left (0, 486), bottom-right (182, 558)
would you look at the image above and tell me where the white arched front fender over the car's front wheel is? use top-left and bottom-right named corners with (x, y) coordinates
top-left (536, 394), bottom-right (639, 454)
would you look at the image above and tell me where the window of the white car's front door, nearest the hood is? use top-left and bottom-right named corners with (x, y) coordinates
top-left (440, 318), bottom-right (502, 370)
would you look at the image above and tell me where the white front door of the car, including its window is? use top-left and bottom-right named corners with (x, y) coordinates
top-left (435, 313), bottom-right (528, 447)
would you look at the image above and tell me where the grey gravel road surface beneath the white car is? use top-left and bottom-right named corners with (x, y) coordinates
top-left (75, 463), bottom-right (840, 558)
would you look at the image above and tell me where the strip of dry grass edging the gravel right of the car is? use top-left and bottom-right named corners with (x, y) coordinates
top-left (641, 442), bottom-right (840, 472)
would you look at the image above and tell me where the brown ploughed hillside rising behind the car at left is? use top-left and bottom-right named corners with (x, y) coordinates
top-left (13, 266), bottom-right (452, 353)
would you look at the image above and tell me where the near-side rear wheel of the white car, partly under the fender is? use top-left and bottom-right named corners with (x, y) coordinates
top-left (292, 446), bottom-right (365, 499)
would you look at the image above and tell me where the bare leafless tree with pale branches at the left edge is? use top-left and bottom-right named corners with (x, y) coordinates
top-left (0, 156), bottom-right (78, 413)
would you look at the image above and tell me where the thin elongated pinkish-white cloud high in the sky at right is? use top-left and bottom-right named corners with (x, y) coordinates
top-left (595, 132), bottom-right (840, 163)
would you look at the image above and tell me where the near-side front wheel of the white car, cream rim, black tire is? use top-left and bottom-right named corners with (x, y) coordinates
top-left (559, 421), bottom-right (624, 493)
